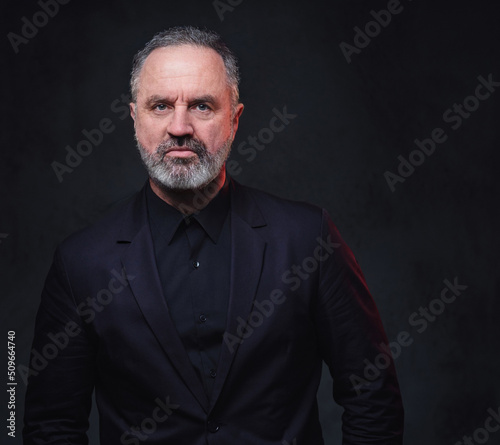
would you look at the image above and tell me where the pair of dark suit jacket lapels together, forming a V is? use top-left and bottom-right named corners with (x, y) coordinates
top-left (117, 181), bottom-right (267, 412)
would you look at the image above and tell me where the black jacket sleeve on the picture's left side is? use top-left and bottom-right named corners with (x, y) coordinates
top-left (23, 250), bottom-right (95, 445)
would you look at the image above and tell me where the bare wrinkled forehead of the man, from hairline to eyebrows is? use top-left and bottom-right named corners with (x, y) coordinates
top-left (138, 45), bottom-right (230, 100)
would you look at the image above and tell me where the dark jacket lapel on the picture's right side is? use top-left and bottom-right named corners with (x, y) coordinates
top-left (210, 181), bottom-right (266, 407)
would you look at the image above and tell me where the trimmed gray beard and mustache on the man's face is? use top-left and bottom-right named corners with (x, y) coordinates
top-left (136, 132), bottom-right (232, 191)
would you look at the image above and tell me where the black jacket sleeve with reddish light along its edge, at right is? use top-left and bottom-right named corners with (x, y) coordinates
top-left (314, 211), bottom-right (404, 445)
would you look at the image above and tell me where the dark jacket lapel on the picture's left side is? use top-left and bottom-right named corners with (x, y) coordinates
top-left (118, 186), bottom-right (208, 411)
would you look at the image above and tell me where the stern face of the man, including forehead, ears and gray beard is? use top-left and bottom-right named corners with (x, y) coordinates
top-left (131, 45), bottom-right (243, 190)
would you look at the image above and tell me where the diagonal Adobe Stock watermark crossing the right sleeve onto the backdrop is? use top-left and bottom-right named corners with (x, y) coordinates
top-left (349, 277), bottom-right (468, 396)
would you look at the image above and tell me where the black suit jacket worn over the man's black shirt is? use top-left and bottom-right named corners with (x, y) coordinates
top-left (24, 181), bottom-right (403, 445)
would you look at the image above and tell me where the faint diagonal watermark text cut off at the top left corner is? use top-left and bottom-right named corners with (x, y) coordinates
top-left (7, 0), bottom-right (71, 54)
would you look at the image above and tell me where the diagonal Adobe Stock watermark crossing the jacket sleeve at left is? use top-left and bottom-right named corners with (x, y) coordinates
top-left (17, 269), bottom-right (135, 385)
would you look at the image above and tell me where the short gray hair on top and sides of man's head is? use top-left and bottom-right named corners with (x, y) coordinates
top-left (130, 26), bottom-right (240, 106)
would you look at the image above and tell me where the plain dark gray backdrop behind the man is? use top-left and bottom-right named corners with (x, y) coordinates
top-left (0, 0), bottom-right (500, 445)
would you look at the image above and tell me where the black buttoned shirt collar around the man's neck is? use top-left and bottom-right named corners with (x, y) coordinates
top-left (146, 175), bottom-right (230, 244)
